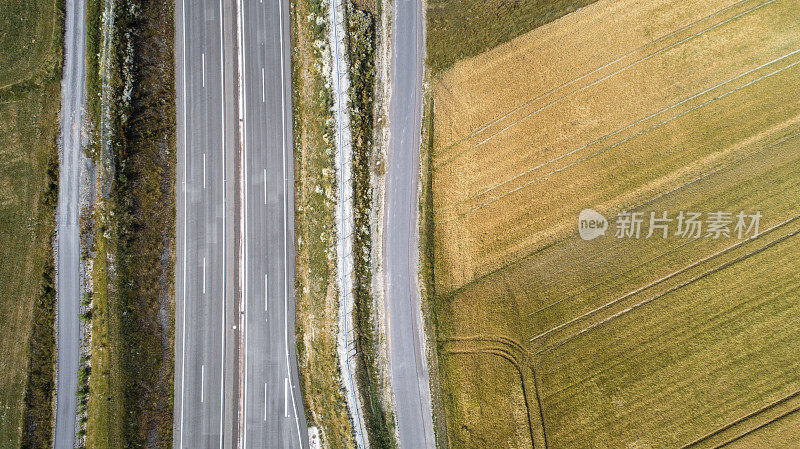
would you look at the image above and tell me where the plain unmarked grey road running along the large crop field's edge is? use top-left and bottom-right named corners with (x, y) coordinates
top-left (383, 0), bottom-right (434, 449)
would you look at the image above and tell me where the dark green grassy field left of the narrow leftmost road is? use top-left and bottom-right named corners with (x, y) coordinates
top-left (0, 0), bottom-right (63, 448)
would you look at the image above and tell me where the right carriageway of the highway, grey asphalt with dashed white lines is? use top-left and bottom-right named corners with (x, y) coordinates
top-left (239, 0), bottom-right (308, 448)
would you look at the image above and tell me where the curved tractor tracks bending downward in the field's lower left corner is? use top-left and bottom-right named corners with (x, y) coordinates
top-left (439, 336), bottom-right (548, 449)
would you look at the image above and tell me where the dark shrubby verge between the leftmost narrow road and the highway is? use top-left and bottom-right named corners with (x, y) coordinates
top-left (86, 0), bottom-right (175, 448)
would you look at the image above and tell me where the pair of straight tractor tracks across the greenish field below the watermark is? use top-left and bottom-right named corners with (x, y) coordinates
top-left (530, 215), bottom-right (800, 356)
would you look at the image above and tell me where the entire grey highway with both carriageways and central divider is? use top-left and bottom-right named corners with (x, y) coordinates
top-left (173, 0), bottom-right (307, 449)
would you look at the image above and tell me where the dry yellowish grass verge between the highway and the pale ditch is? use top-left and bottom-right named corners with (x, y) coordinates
top-left (291, 0), bottom-right (355, 448)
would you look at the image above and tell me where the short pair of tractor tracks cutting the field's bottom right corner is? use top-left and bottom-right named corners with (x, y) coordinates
top-left (681, 391), bottom-right (800, 449)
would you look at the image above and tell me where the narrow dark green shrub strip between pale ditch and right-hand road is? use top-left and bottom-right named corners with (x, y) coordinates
top-left (347, 2), bottom-right (396, 448)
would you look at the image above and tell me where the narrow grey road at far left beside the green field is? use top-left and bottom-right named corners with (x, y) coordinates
top-left (54, 0), bottom-right (86, 449)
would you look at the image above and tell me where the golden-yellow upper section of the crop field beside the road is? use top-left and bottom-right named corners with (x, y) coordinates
top-left (433, 0), bottom-right (800, 292)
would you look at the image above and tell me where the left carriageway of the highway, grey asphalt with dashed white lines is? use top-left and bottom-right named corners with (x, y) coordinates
top-left (173, 0), bottom-right (236, 449)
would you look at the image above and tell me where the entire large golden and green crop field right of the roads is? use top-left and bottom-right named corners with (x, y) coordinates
top-left (426, 0), bottom-right (800, 449)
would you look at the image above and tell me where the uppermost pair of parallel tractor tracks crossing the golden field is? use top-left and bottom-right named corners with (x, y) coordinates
top-left (434, 0), bottom-right (777, 168)
